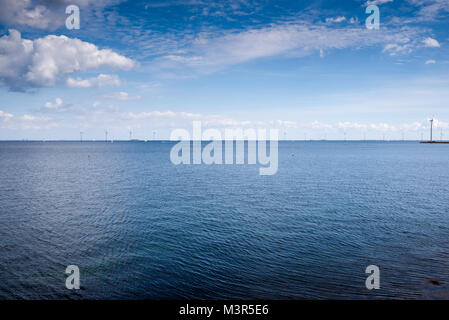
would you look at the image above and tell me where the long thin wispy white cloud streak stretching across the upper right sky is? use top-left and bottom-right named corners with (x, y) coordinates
top-left (155, 22), bottom-right (423, 75)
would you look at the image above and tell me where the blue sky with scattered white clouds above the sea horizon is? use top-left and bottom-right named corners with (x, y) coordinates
top-left (0, 0), bottom-right (449, 140)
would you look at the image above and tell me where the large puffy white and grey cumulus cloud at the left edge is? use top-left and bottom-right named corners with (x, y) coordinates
top-left (0, 29), bottom-right (135, 90)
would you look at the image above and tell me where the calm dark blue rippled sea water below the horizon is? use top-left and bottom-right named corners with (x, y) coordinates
top-left (0, 141), bottom-right (449, 299)
